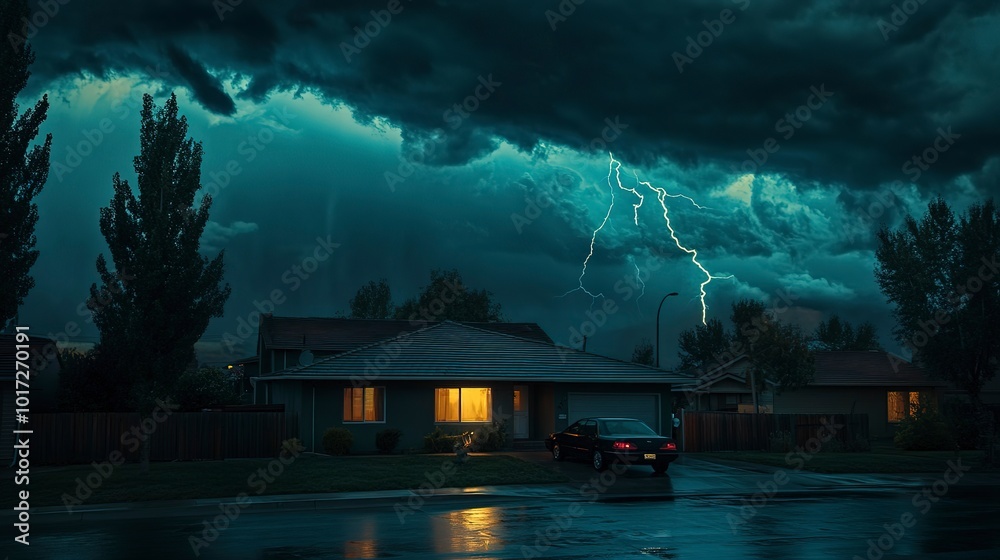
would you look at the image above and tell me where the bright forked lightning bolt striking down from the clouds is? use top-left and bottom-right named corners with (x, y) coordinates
top-left (559, 152), bottom-right (733, 325)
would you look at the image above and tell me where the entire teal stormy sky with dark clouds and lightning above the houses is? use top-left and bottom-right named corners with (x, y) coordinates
top-left (13, 0), bottom-right (1000, 367)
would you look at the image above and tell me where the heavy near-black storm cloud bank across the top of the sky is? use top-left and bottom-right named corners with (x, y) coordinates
top-left (25, 0), bottom-right (1000, 201)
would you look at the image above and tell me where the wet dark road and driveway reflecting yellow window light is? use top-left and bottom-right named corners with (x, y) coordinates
top-left (9, 463), bottom-right (1000, 560)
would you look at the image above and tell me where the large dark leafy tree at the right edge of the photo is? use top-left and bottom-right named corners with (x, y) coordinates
top-left (875, 198), bottom-right (1000, 406)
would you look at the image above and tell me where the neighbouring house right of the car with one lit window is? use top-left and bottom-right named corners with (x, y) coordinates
top-left (674, 351), bottom-right (947, 438)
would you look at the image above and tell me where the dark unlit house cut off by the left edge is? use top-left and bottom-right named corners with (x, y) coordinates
top-left (0, 331), bottom-right (59, 466)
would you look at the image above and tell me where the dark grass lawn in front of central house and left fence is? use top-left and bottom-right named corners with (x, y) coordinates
top-left (0, 455), bottom-right (567, 507)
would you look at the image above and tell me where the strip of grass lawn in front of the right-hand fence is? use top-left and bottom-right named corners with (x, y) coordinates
top-left (690, 445), bottom-right (996, 473)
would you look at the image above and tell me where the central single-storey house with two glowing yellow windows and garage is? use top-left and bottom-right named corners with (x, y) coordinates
top-left (253, 315), bottom-right (690, 453)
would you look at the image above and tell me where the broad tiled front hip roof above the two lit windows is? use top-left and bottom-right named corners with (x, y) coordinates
top-left (258, 321), bottom-right (690, 383)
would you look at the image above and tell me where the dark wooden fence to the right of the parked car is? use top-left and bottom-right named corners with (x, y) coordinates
top-left (681, 411), bottom-right (869, 452)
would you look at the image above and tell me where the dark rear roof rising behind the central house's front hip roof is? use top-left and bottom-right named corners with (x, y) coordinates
top-left (260, 313), bottom-right (552, 353)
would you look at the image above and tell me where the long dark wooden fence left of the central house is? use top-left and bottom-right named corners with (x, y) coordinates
top-left (31, 412), bottom-right (299, 465)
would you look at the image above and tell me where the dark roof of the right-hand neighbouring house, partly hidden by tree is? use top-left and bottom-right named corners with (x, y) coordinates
top-left (673, 350), bottom-right (947, 391)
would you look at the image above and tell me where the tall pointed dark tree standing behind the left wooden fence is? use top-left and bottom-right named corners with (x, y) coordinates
top-left (87, 95), bottom-right (230, 471)
